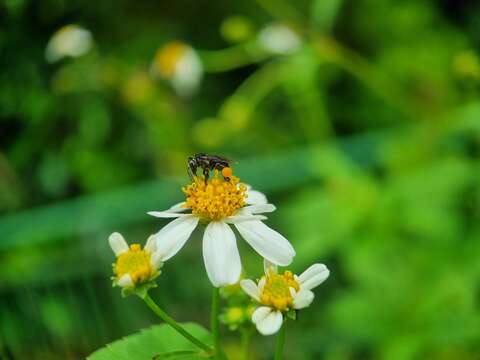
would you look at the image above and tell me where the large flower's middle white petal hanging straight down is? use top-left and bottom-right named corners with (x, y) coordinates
top-left (203, 221), bottom-right (242, 287)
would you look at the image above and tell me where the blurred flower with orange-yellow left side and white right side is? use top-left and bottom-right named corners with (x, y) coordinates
top-left (151, 41), bottom-right (203, 97)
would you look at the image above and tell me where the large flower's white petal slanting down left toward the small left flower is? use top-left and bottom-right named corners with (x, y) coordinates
top-left (155, 215), bottom-right (199, 261)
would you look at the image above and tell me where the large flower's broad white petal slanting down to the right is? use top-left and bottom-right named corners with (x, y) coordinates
top-left (235, 220), bottom-right (295, 266)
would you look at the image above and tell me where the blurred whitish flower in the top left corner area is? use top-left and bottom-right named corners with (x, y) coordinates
top-left (45, 25), bottom-right (93, 63)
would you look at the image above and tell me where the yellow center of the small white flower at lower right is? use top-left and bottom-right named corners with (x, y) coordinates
top-left (260, 271), bottom-right (300, 311)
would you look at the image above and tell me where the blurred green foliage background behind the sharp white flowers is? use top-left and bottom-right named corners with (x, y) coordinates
top-left (0, 0), bottom-right (480, 360)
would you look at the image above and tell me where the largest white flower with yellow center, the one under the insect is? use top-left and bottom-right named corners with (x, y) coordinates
top-left (148, 168), bottom-right (295, 287)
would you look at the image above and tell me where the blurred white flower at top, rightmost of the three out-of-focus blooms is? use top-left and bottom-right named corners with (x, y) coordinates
top-left (258, 23), bottom-right (302, 55)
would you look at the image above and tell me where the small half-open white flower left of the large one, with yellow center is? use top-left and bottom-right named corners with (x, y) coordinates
top-left (108, 232), bottom-right (162, 289)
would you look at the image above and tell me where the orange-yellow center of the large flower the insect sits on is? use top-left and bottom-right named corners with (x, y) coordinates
top-left (182, 171), bottom-right (247, 220)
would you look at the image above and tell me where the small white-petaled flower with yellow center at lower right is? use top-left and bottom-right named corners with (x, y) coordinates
top-left (240, 261), bottom-right (330, 335)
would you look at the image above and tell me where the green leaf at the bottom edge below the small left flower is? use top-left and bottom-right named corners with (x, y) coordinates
top-left (87, 323), bottom-right (211, 360)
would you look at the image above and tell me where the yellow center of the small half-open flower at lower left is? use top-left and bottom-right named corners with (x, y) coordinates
top-left (113, 244), bottom-right (155, 285)
